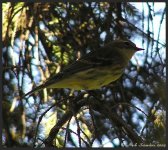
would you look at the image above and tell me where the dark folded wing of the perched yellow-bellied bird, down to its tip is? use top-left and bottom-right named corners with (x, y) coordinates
top-left (46, 45), bottom-right (121, 86)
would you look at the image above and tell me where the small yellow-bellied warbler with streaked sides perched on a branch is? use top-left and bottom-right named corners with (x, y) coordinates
top-left (24, 40), bottom-right (144, 97)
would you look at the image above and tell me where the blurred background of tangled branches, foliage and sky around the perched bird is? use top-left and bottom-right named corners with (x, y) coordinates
top-left (2, 2), bottom-right (166, 148)
